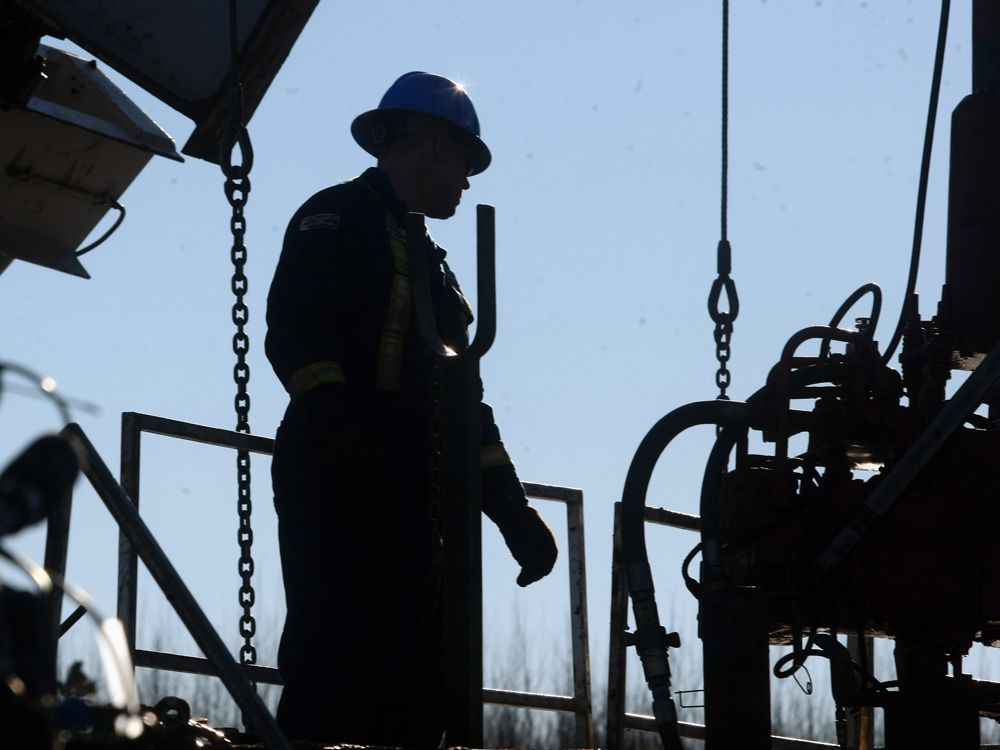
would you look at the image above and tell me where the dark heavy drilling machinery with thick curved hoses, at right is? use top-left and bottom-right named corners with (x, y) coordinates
top-left (623, 0), bottom-right (1000, 750)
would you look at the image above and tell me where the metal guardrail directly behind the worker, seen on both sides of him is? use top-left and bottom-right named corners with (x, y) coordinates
top-left (118, 412), bottom-right (594, 747)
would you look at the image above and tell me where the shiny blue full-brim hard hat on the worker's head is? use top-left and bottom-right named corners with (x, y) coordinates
top-left (351, 71), bottom-right (493, 175)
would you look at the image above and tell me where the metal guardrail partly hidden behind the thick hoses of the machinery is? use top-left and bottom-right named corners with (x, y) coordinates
top-left (607, 502), bottom-right (840, 750)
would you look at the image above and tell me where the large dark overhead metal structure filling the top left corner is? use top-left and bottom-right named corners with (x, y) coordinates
top-left (0, 0), bottom-right (317, 278)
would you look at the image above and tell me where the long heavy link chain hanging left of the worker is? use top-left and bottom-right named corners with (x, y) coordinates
top-left (222, 120), bottom-right (257, 664)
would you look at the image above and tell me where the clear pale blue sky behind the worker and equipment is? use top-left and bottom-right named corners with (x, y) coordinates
top-left (0, 0), bottom-right (984, 740)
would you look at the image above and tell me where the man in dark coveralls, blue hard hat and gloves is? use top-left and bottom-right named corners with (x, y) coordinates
top-left (266, 72), bottom-right (557, 746)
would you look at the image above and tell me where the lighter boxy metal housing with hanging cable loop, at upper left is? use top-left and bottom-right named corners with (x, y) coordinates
top-left (0, 45), bottom-right (182, 278)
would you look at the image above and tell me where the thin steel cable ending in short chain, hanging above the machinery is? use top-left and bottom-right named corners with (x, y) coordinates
top-left (708, 0), bottom-right (740, 401)
